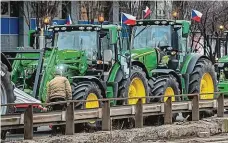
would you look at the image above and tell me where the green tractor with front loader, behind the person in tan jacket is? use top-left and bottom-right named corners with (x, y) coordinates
top-left (5, 25), bottom-right (144, 130)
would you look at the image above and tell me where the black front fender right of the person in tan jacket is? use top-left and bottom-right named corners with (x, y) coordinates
top-left (71, 76), bottom-right (106, 96)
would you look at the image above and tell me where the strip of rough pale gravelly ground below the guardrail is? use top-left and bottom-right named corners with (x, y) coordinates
top-left (8, 117), bottom-right (227, 143)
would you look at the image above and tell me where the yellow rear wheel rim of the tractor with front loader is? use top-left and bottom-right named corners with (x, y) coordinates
top-left (128, 77), bottom-right (146, 105)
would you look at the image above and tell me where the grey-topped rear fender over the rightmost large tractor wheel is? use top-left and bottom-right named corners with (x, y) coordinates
top-left (186, 54), bottom-right (210, 74)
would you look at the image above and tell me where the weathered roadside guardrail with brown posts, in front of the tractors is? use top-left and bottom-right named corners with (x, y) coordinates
top-left (1, 92), bottom-right (228, 139)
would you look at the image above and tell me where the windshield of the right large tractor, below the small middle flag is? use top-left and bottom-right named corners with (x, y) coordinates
top-left (133, 25), bottom-right (171, 49)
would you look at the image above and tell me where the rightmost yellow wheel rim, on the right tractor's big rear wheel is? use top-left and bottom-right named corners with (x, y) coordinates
top-left (200, 73), bottom-right (214, 99)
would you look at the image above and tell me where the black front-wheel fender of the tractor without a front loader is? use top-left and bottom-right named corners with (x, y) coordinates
top-left (151, 69), bottom-right (182, 91)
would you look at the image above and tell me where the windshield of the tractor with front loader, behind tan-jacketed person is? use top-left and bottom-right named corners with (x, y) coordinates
top-left (55, 31), bottom-right (97, 59)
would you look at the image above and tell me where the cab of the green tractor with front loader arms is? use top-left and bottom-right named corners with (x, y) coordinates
top-left (48, 24), bottom-right (122, 78)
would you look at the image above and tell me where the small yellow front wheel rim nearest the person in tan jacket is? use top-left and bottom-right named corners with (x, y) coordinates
top-left (85, 93), bottom-right (99, 124)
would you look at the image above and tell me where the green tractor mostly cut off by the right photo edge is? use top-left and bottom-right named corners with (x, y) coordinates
top-left (217, 56), bottom-right (228, 97)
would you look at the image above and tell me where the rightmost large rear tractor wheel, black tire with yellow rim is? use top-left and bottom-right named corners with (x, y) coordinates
top-left (186, 58), bottom-right (217, 120)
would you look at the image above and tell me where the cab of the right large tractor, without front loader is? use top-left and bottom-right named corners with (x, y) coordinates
top-left (131, 20), bottom-right (190, 70)
